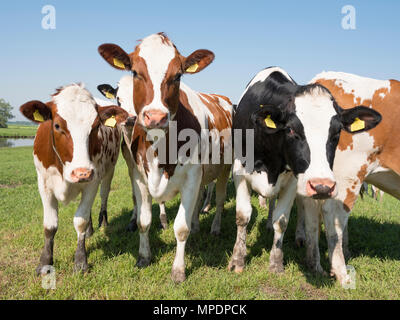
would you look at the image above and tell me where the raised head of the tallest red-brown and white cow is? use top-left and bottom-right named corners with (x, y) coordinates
top-left (99, 33), bottom-right (214, 129)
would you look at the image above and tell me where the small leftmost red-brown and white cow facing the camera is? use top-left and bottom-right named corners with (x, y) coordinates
top-left (20, 84), bottom-right (128, 274)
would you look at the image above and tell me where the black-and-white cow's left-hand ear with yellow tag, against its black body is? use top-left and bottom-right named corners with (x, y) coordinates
top-left (251, 105), bottom-right (286, 134)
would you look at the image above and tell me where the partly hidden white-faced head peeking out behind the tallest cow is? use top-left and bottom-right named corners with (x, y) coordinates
top-left (97, 75), bottom-right (136, 126)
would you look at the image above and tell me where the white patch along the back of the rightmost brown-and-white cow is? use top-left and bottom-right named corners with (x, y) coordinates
top-left (310, 71), bottom-right (390, 104)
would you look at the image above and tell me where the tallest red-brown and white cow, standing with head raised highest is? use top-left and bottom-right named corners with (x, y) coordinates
top-left (98, 33), bottom-right (233, 283)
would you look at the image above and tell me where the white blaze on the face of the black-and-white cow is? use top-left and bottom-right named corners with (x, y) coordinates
top-left (295, 88), bottom-right (336, 195)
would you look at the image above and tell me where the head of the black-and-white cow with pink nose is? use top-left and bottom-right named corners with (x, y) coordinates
top-left (252, 85), bottom-right (381, 199)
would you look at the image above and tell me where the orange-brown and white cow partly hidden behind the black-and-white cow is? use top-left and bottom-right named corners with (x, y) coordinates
top-left (290, 72), bottom-right (400, 285)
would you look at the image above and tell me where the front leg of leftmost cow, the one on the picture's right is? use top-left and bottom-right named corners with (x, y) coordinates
top-left (74, 183), bottom-right (99, 272)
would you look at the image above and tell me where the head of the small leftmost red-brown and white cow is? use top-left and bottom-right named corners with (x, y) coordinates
top-left (20, 84), bottom-right (128, 183)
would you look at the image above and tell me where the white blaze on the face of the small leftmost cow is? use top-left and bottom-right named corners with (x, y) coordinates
top-left (53, 84), bottom-right (97, 180)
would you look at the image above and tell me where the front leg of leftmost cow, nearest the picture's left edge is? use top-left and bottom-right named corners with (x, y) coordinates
top-left (36, 179), bottom-right (58, 275)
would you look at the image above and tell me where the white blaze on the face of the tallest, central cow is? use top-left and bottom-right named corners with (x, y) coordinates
top-left (139, 34), bottom-right (176, 113)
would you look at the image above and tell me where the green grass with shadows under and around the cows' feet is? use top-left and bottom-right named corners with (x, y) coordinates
top-left (0, 147), bottom-right (400, 299)
